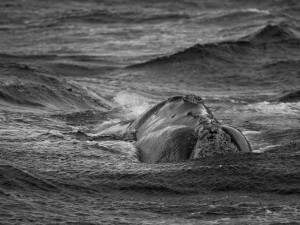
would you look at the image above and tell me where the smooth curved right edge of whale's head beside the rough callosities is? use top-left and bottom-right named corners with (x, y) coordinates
top-left (221, 125), bottom-right (252, 152)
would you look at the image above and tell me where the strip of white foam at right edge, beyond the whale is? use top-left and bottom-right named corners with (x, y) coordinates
top-left (246, 102), bottom-right (300, 115)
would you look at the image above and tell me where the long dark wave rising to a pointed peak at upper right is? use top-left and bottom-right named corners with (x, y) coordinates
top-left (129, 24), bottom-right (300, 68)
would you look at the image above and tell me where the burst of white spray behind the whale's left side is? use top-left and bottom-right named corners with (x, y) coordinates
top-left (114, 91), bottom-right (152, 119)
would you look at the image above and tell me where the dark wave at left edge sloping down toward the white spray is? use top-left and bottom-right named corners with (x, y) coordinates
top-left (0, 62), bottom-right (110, 111)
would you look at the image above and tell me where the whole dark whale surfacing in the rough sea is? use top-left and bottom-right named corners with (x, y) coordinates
top-left (95, 95), bottom-right (252, 163)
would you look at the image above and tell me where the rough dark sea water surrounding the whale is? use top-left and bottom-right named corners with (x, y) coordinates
top-left (0, 0), bottom-right (300, 225)
